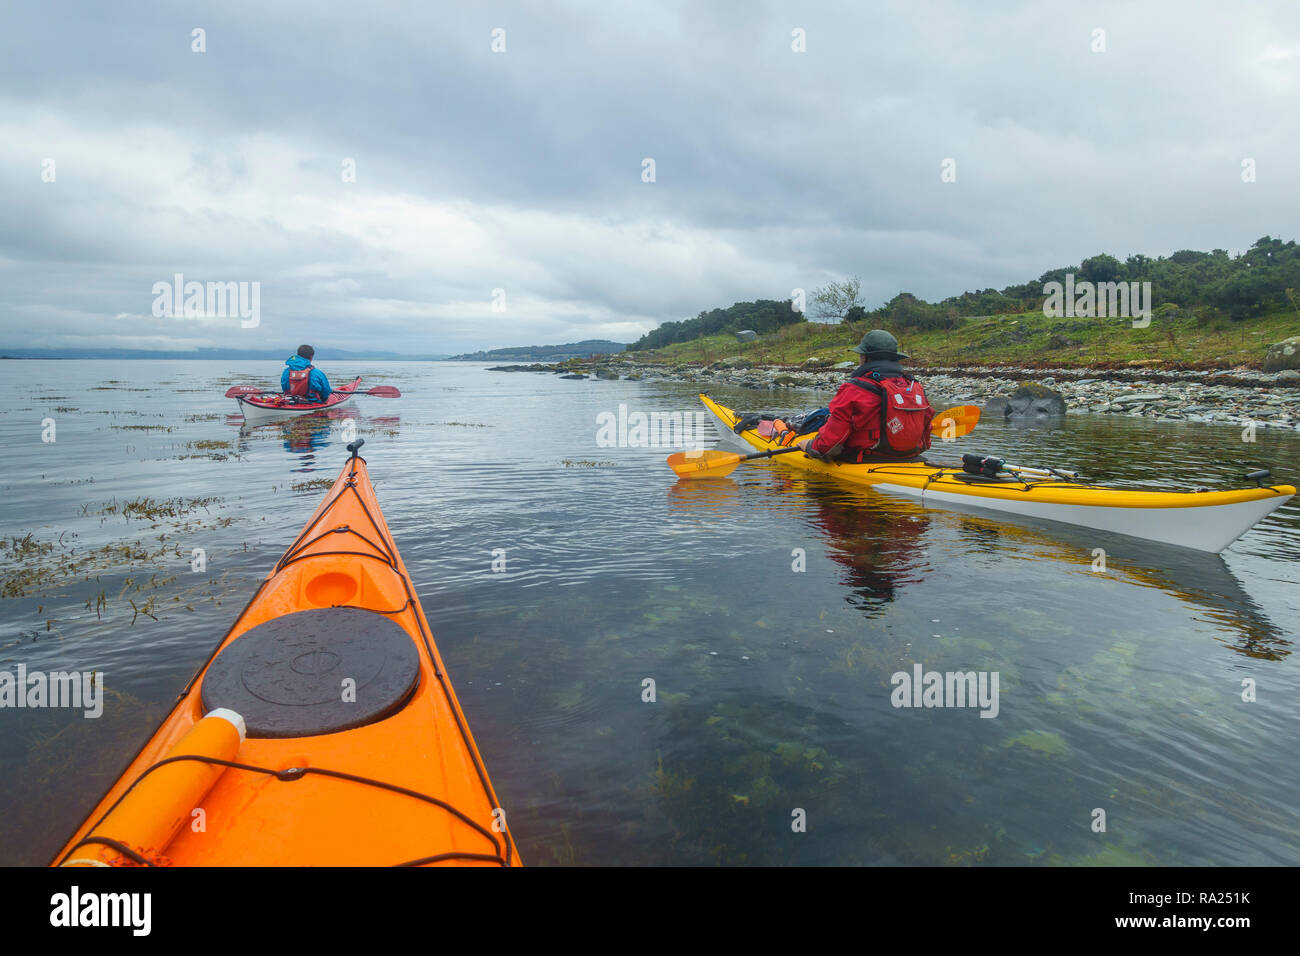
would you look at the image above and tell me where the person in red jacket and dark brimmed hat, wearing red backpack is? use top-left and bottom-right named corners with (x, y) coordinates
top-left (800, 329), bottom-right (935, 462)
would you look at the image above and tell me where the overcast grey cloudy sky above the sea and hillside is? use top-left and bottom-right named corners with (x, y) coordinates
top-left (0, 0), bottom-right (1300, 358)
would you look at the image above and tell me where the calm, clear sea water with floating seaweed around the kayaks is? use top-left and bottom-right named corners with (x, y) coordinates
top-left (0, 362), bottom-right (1300, 865)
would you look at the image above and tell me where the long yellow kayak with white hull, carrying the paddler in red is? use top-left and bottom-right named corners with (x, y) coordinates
top-left (699, 394), bottom-right (1296, 551)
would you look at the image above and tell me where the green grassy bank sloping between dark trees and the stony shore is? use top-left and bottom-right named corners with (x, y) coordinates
top-left (627, 310), bottom-right (1300, 368)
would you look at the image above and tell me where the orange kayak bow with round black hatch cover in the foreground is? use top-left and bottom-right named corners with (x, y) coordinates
top-left (55, 442), bottom-right (520, 866)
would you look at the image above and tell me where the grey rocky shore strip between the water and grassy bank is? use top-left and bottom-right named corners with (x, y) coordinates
top-left (494, 358), bottom-right (1300, 432)
